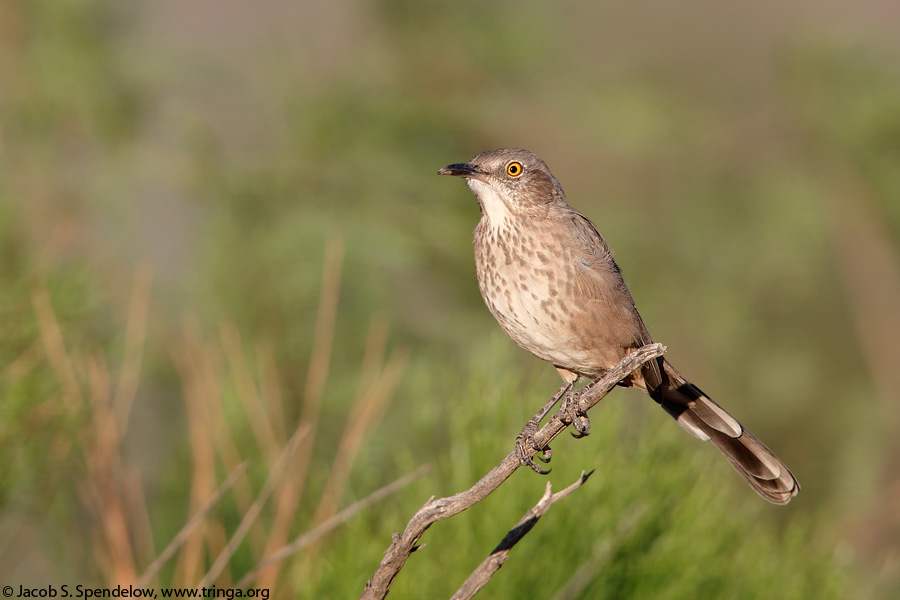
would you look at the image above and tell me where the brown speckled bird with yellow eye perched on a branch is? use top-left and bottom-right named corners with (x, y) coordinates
top-left (438, 148), bottom-right (800, 504)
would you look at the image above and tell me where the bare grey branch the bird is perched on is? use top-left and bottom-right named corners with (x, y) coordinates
top-left (360, 344), bottom-right (666, 600)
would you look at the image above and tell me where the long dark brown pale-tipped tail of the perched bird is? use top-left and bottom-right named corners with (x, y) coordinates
top-left (644, 359), bottom-right (800, 504)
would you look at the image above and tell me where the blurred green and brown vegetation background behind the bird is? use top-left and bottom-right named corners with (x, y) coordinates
top-left (0, 0), bottom-right (900, 599)
